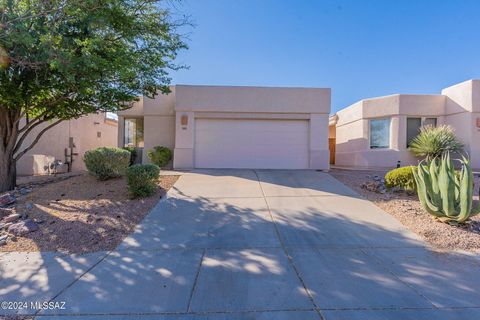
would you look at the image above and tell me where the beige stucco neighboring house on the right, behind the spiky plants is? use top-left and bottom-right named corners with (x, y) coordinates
top-left (329, 80), bottom-right (480, 169)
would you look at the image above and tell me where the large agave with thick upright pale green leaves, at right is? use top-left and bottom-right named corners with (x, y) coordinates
top-left (413, 153), bottom-right (480, 223)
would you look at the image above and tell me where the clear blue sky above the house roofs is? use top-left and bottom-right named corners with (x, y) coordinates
top-left (172, 0), bottom-right (480, 113)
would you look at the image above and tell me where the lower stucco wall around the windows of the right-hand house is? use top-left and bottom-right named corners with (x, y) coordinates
top-left (335, 94), bottom-right (446, 168)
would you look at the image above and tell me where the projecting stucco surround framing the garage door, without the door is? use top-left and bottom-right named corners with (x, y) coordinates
top-left (174, 85), bottom-right (330, 169)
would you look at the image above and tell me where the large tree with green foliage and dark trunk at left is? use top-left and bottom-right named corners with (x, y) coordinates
top-left (0, 0), bottom-right (188, 192)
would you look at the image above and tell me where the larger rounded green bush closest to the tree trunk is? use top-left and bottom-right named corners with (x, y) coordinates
top-left (83, 147), bottom-right (130, 180)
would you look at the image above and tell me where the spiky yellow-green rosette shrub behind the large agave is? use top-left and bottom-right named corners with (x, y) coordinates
top-left (410, 125), bottom-right (463, 161)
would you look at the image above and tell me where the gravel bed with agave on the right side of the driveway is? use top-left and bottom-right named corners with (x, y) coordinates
top-left (330, 169), bottom-right (480, 253)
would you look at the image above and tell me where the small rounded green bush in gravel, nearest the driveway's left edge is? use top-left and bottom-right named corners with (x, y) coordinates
top-left (127, 164), bottom-right (160, 198)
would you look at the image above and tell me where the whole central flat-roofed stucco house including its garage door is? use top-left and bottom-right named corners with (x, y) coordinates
top-left (118, 85), bottom-right (330, 169)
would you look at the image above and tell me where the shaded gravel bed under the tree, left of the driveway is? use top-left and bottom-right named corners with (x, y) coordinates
top-left (0, 173), bottom-right (178, 253)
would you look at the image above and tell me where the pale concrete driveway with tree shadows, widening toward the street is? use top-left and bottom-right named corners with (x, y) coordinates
top-left (0, 170), bottom-right (480, 320)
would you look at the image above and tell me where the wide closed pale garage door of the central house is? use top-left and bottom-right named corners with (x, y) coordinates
top-left (194, 119), bottom-right (309, 169)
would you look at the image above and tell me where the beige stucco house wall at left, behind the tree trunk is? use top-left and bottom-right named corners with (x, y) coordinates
top-left (17, 113), bottom-right (118, 175)
